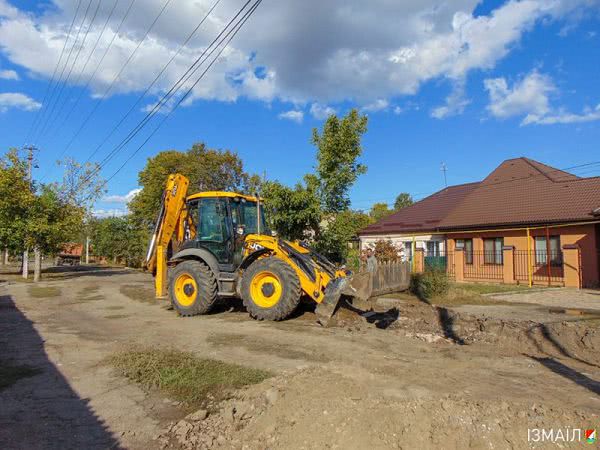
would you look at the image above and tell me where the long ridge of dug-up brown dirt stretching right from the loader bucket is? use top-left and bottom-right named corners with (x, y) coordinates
top-left (332, 302), bottom-right (600, 364)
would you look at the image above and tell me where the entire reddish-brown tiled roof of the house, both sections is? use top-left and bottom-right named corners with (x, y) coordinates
top-left (359, 158), bottom-right (600, 235)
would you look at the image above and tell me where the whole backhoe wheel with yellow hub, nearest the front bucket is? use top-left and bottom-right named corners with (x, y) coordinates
top-left (242, 257), bottom-right (302, 320)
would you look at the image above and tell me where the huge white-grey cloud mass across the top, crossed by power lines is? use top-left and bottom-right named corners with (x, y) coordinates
top-left (0, 0), bottom-right (597, 111)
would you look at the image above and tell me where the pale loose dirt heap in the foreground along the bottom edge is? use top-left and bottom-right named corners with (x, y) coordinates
top-left (157, 368), bottom-right (598, 450)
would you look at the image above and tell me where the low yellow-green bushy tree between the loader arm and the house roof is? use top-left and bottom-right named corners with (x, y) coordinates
top-left (315, 210), bottom-right (372, 263)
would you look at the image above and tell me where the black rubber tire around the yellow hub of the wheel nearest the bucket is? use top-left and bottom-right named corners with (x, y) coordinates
top-left (242, 257), bottom-right (302, 320)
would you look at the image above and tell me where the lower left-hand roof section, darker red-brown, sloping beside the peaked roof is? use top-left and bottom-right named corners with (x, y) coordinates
top-left (359, 183), bottom-right (479, 235)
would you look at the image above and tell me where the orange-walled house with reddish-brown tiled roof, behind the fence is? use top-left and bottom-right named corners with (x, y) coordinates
top-left (359, 158), bottom-right (600, 287)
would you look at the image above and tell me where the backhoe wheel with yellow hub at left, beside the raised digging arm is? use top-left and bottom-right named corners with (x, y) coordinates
top-left (169, 261), bottom-right (217, 316)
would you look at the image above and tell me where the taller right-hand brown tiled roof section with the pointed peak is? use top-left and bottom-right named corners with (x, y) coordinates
top-left (439, 158), bottom-right (600, 229)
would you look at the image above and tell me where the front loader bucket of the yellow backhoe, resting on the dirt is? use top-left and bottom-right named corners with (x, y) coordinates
top-left (315, 273), bottom-right (373, 327)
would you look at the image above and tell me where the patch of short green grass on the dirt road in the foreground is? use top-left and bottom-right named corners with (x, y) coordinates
top-left (110, 349), bottom-right (272, 407)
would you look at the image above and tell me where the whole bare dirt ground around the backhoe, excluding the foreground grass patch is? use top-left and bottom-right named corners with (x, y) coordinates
top-left (0, 269), bottom-right (600, 449)
